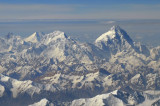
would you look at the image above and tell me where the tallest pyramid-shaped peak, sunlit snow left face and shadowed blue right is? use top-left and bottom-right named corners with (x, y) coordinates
top-left (95, 26), bottom-right (134, 54)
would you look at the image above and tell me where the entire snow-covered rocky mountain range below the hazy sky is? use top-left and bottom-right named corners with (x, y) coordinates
top-left (0, 26), bottom-right (160, 106)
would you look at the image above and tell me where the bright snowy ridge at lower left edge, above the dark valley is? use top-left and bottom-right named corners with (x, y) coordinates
top-left (0, 74), bottom-right (40, 98)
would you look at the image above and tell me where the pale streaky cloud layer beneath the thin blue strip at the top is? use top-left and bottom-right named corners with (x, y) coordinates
top-left (0, 4), bottom-right (160, 19)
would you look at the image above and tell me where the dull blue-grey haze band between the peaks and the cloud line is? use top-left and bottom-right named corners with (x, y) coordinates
top-left (0, 20), bottom-right (160, 46)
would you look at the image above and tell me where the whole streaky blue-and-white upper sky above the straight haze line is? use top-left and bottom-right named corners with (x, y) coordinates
top-left (0, 0), bottom-right (160, 19)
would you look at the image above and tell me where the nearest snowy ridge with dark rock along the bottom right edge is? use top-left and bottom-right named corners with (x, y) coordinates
top-left (70, 90), bottom-right (160, 106)
